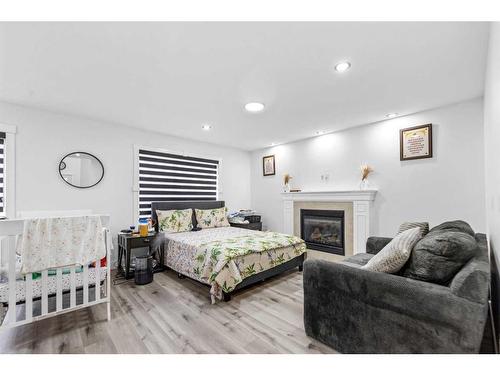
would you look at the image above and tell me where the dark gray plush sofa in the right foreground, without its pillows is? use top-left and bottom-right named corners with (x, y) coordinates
top-left (304, 222), bottom-right (490, 353)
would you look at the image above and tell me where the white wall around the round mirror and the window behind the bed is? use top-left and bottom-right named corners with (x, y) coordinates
top-left (0, 102), bottom-right (250, 262)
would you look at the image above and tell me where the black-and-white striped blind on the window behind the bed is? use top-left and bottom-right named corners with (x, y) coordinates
top-left (139, 149), bottom-right (219, 218)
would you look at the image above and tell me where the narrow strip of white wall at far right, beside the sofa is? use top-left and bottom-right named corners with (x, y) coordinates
top-left (484, 22), bottom-right (500, 348)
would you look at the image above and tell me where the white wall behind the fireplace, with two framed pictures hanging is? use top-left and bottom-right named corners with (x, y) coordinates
top-left (252, 99), bottom-right (486, 236)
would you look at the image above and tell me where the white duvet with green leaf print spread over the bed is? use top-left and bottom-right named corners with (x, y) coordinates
top-left (165, 227), bottom-right (306, 301)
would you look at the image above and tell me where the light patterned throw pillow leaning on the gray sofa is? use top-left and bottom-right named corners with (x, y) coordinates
top-left (361, 228), bottom-right (422, 273)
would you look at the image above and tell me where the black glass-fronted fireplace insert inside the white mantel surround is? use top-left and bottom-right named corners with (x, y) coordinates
top-left (300, 209), bottom-right (345, 255)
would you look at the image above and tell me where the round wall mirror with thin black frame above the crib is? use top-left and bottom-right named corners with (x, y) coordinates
top-left (59, 152), bottom-right (104, 189)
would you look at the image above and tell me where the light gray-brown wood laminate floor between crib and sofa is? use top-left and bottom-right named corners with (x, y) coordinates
top-left (0, 271), bottom-right (334, 353)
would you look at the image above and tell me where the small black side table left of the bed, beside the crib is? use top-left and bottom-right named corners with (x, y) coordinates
top-left (118, 233), bottom-right (165, 279)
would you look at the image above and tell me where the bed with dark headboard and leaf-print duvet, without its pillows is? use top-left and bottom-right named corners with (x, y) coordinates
top-left (151, 201), bottom-right (306, 302)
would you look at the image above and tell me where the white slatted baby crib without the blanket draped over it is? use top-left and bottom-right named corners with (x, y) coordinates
top-left (0, 215), bottom-right (111, 331)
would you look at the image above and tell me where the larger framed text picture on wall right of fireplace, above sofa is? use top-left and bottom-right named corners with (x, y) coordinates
top-left (399, 124), bottom-right (432, 160)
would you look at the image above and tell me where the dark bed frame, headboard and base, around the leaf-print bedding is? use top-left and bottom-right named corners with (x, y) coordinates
top-left (151, 201), bottom-right (305, 302)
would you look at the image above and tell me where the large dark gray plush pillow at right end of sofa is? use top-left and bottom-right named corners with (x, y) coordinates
top-left (403, 230), bottom-right (478, 285)
